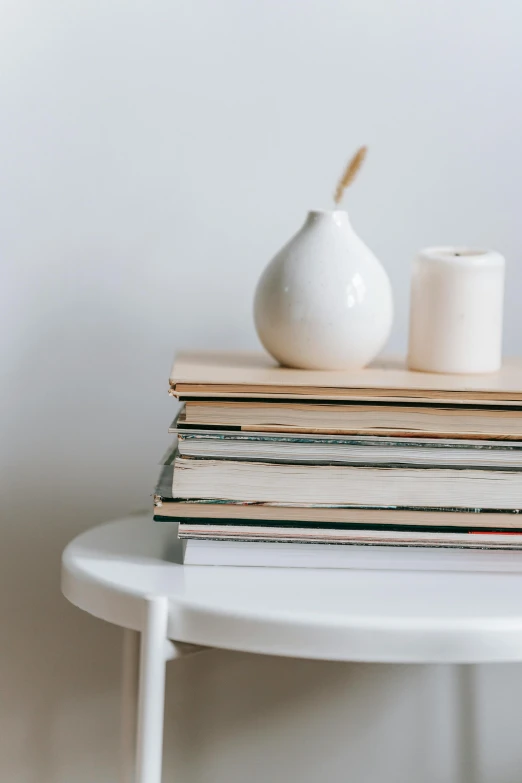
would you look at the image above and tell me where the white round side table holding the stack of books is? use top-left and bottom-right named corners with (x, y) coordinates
top-left (62, 515), bottom-right (522, 783)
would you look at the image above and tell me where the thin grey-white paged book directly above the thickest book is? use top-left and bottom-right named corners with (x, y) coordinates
top-left (172, 432), bottom-right (522, 468)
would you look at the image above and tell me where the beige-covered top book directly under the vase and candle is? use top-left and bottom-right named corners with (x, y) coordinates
top-left (170, 352), bottom-right (522, 405)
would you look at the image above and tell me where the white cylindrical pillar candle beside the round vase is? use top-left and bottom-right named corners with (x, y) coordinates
top-left (408, 247), bottom-right (505, 373)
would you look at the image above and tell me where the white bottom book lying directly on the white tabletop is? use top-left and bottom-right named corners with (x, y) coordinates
top-left (184, 539), bottom-right (522, 573)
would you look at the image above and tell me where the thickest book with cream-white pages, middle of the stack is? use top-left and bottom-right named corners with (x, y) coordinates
top-left (172, 457), bottom-right (522, 509)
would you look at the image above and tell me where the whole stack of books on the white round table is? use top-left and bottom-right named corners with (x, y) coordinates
top-left (155, 353), bottom-right (522, 569)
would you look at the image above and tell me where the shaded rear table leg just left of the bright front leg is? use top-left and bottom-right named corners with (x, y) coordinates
top-left (121, 628), bottom-right (140, 783)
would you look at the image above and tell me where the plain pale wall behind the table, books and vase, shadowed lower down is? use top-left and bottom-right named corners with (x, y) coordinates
top-left (0, 0), bottom-right (522, 783)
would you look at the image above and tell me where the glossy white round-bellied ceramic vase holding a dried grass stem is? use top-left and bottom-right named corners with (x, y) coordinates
top-left (254, 210), bottom-right (393, 370)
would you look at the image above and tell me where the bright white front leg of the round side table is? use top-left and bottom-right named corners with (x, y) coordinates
top-left (136, 597), bottom-right (168, 783)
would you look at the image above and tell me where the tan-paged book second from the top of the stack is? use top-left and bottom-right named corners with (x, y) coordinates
top-left (178, 400), bottom-right (522, 440)
